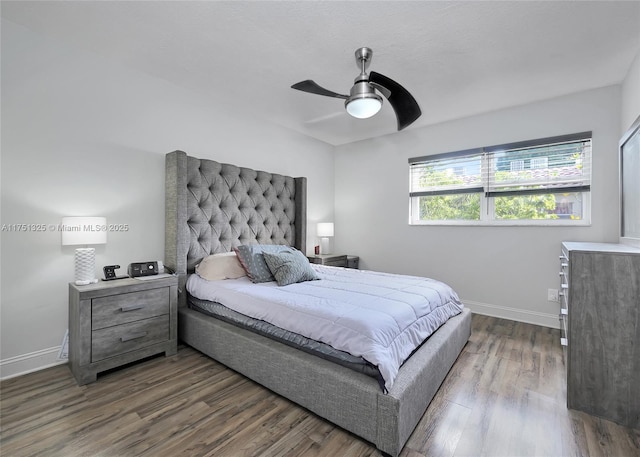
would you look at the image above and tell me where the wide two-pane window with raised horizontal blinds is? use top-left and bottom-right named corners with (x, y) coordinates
top-left (409, 132), bottom-right (591, 225)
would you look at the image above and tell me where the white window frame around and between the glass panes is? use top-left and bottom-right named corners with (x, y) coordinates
top-left (409, 132), bottom-right (592, 227)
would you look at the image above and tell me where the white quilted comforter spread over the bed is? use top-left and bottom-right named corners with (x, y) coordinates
top-left (187, 265), bottom-right (463, 390)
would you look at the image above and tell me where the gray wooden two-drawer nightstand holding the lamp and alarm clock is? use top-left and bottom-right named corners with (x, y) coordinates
top-left (69, 276), bottom-right (178, 385)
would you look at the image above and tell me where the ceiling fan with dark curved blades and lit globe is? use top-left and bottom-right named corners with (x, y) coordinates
top-left (291, 47), bottom-right (422, 130)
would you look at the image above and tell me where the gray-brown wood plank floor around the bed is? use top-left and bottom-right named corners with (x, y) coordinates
top-left (0, 315), bottom-right (640, 457)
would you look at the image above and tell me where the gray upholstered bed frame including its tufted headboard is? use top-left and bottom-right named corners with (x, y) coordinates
top-left (165, 151), bottom-right (471, 456)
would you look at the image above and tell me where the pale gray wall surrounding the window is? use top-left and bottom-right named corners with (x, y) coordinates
top-left (335, 86), bottom-right (620, 327)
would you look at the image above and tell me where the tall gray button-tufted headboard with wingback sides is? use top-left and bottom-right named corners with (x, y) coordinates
top-left (165, 151), bottom-right (307, 305)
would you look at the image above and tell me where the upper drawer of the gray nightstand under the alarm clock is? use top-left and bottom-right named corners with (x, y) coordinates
top-left (91, 287), bottom-right (170, 330)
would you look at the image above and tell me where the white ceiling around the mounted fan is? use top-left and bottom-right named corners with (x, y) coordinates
top-left (0, 1), bottom-right (640, 145)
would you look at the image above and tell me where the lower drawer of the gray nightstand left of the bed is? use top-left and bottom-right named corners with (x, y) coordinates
top-left (91, 315), bottom-right (169, 362)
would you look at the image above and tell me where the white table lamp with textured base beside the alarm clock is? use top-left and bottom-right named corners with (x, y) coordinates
top-left (60, 216), bottom-right (107, 286)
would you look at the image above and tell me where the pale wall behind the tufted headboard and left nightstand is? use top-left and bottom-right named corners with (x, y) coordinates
top-left (0, 20), bottom-right (334, 377)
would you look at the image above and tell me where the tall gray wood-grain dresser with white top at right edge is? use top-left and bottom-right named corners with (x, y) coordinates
top-left (560, 242), bottom-right (640, 428)
